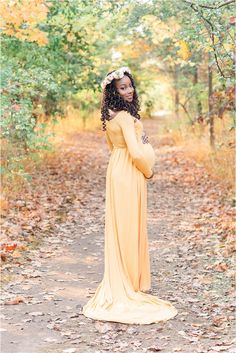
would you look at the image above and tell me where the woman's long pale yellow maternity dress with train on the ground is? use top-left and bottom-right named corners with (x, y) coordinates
top-left (82, 111), bottom-right (178, 324)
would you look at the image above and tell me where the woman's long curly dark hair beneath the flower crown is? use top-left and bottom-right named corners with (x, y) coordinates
top-left (101, 70), bottom-right (141, 131)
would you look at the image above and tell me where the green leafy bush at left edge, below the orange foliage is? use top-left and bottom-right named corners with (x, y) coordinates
top-left (1, 57), bottom-right (57, 148)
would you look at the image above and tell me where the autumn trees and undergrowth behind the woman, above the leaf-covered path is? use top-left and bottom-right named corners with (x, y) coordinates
top-left (0, 0), bottom-right (235, 186)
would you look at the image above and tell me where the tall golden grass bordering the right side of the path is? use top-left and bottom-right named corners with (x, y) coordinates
top-left (161, 114), bottom-right (235, 191)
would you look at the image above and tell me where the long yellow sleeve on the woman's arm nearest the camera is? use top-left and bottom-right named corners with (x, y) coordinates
top-left (119, 111), bottom-right (152, 178)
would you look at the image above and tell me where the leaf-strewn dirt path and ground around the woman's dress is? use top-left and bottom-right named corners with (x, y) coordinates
top-left (0, 120), bottom-right (236, 353)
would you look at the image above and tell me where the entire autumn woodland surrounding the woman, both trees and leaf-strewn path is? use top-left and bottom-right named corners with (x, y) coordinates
top-left (0, 0), bottom-right (236, 353)
